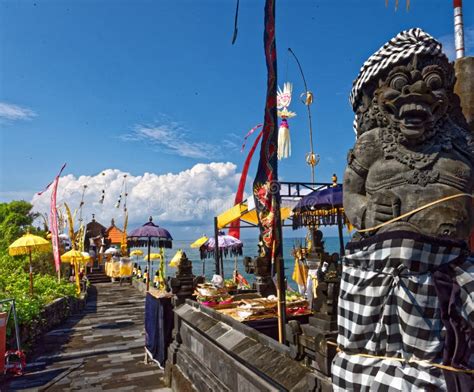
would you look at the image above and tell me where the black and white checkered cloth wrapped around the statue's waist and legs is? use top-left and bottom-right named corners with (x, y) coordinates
top-left (332, 232), bottom-right (474, 392)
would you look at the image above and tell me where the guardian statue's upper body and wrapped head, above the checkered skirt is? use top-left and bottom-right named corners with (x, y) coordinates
top-left (344, 29), bottom-right (474, 240)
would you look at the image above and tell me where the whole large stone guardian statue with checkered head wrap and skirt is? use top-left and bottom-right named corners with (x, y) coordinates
top-left (332, 28), bottom-right (474, 391)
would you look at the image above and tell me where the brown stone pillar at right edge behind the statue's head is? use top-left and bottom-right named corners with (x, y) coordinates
top-left (454, 57), bottom-right (474, 132)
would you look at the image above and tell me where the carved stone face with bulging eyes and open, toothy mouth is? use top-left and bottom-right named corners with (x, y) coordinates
top-left (376, 64), bottom-right (449, 144)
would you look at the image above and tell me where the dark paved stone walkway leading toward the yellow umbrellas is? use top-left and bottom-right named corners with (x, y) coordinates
top-left (0, 283), bottom-right (171, 392)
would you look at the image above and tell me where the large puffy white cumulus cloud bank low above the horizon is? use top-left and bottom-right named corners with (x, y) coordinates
top-left (32, 162), bottom-right (240, 238)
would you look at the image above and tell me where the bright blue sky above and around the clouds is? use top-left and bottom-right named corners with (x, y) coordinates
top-left (0, 0), bottom-right (474, 237)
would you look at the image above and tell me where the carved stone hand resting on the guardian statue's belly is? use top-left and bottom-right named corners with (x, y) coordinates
top-left (365, 191), bottom-right (400, 228)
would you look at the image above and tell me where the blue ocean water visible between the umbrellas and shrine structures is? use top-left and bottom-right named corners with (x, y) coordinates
top-left (132, 237), bottom-right (348, 288)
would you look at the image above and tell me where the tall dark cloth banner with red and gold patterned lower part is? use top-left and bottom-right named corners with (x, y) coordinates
top-left (253, 0), bottom-right (282, 260)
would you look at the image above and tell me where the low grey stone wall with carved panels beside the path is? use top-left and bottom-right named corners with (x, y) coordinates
top-left (166, 300), bottom-right (315, 392)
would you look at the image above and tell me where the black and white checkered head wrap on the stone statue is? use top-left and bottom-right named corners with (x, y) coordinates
top-left (350, 28), bottom-right (447, 109)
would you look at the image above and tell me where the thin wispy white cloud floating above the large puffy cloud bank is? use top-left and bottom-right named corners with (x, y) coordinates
top-left (120, 121), bottom-right (236, 159)
